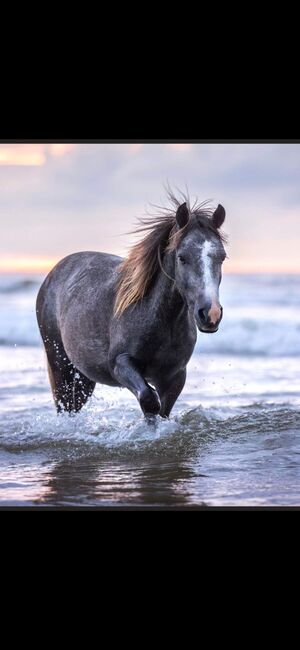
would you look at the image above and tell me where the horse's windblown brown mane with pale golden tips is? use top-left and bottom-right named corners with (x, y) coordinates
top-left (114, 190), bottom-right (226, 316)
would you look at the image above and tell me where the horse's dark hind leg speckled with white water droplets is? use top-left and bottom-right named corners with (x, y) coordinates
top-left (46, 343), bottom-right (96, 413)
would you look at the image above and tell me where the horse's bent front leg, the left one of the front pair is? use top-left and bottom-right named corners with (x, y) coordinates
top-left (111, 353), bottom-right (161, 416)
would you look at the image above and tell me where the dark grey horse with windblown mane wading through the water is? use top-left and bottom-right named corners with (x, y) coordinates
top-left (36, 194), bottom-right (226, 420)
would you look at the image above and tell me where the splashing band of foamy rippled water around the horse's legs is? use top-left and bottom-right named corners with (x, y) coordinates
top-left (0, 394), bottom-right (300, 456)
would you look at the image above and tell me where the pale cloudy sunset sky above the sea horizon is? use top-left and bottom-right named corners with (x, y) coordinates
top-left (0, 143), bottom-right (300, 273)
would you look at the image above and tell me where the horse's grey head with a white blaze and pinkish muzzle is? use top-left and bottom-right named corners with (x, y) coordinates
top-left (175, 203), bottom-right (226, 332)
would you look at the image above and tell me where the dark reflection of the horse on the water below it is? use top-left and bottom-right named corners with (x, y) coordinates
top-left (38, 457), bottom-right (199, 506)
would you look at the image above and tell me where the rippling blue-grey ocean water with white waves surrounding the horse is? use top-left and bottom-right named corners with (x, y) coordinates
top-left (0, 275), bottom-right (300, 507)
